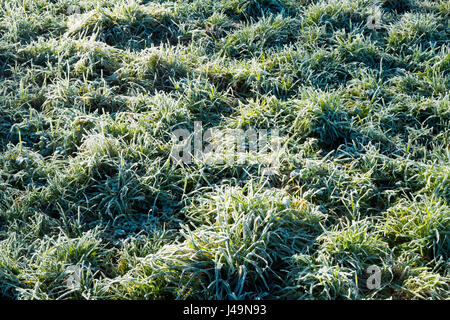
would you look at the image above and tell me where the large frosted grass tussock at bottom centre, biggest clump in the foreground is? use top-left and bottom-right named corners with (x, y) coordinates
top-left (106, 185), bottom-right (325, 299)
